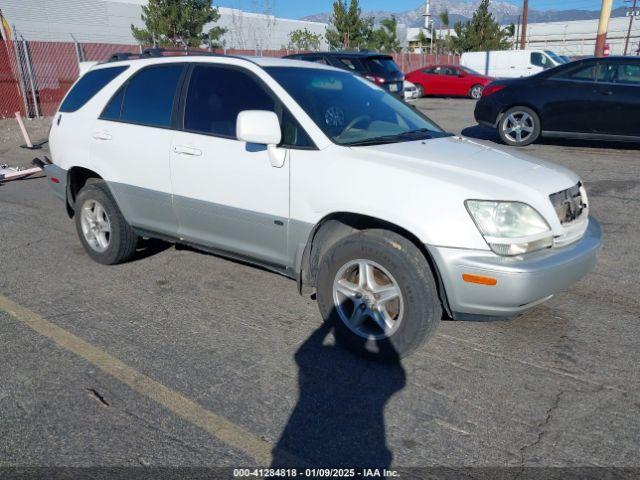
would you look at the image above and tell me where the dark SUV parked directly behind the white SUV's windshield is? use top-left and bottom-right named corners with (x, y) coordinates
top-left (284, 52), bottom-right (404, 98)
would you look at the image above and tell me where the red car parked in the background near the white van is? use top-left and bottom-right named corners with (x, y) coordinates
top-left (405, 65), bottom-right (494, 100)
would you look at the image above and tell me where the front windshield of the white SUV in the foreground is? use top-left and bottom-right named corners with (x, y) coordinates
top-left (266, 67), bottom-right (448, 146)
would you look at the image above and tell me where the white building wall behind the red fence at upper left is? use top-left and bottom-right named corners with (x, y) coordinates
top-left (0, 0), bottom-right (327, 50)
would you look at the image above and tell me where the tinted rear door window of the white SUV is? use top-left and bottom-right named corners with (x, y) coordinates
top-left (119, 64), bottom-right (184, 128)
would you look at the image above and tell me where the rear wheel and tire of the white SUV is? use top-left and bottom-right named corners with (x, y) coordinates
top-left (74, 180), bottom-right (138, 265)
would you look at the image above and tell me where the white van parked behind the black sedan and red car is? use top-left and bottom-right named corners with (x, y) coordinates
top-left (460, 50), bottom-right (564, 78)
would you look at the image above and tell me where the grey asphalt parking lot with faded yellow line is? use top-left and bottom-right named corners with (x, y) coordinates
top-left (0, 98), bottom-right (640, 478)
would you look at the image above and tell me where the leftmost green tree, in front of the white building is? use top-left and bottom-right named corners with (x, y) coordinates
top-left (131, 0), bottom-right (227, 47)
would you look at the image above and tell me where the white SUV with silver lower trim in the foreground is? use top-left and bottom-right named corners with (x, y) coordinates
top-left (46, 55), bottom-right (600, 358)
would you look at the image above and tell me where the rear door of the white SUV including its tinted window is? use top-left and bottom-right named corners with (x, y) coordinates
top-left (91, 63), bottom-right (185, 237)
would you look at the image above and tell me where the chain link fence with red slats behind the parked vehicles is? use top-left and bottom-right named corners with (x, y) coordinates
top-left (0, 31), bottom-right (459, 118)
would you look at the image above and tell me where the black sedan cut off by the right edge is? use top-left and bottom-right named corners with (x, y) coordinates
top-left (475, 57), bottom-right (640, 146)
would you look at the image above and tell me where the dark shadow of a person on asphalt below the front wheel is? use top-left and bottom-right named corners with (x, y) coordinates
top-left (272, 325), bottom-right (406, 468)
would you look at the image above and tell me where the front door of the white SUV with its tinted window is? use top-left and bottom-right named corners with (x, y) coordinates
top-left (171, 64), bottom-right (290, 267)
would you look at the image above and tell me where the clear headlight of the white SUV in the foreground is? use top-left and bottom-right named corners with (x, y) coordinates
top-left (464, 200), bottom-right (553, 255)
